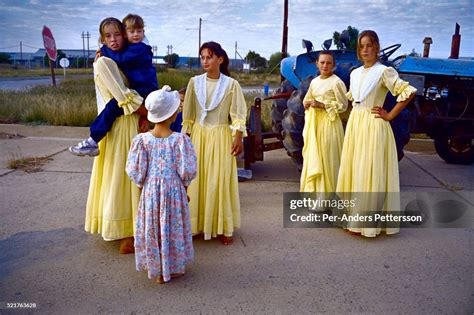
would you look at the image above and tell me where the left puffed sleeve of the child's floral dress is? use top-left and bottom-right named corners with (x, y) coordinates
top-left (125, 135), bottom-right (148, 188)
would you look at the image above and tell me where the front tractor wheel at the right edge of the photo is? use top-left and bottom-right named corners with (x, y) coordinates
top-left (434, 125), bottom-right (474, 165)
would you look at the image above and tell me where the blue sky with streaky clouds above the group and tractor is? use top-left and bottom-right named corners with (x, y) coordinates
top-left (0, 0), bottom-right (474, 59)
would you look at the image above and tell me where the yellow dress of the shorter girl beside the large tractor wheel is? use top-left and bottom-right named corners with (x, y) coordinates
top-left (300, 74), bottom-right (347, 193)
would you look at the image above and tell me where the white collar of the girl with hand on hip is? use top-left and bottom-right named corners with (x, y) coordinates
top-left (351, 62), bottom-right (387, 103)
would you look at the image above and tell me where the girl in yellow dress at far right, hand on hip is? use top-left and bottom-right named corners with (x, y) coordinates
top-left (337, 30), bottom-right (416, 237)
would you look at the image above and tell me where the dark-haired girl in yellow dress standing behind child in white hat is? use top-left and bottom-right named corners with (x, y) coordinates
top-left (181, 42), bottom-right (247, 245)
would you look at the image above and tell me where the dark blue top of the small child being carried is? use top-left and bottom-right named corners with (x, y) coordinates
top-left (100, 43), bottom-right (158, 98)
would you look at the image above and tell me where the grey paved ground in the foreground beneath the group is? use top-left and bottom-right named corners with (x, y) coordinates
top-left (0, 125), bottom-right (474, 314)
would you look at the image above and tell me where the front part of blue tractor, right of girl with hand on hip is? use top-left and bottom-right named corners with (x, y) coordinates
top-left (394, 56), bottom-right (474, 164)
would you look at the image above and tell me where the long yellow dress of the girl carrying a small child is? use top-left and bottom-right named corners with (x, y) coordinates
top-left (85, 57), bottom-right (143, 241)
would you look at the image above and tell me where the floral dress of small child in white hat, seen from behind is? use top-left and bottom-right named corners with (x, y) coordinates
top-left (126, 132), bottom-right (196, 281)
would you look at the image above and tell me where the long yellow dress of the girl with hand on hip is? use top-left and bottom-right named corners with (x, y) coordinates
top-left (337, 67), bottom-right (416, 237)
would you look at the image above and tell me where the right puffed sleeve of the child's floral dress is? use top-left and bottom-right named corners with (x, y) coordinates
top-left (175, 134), bottom-right (197, 187)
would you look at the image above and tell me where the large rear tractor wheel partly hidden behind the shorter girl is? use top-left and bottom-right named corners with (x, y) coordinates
top-left (281, 77), bottom-right (313, 165)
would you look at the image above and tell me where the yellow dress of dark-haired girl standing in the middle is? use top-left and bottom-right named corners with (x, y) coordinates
top-left (181, 78), bottom-right (247, 240)
